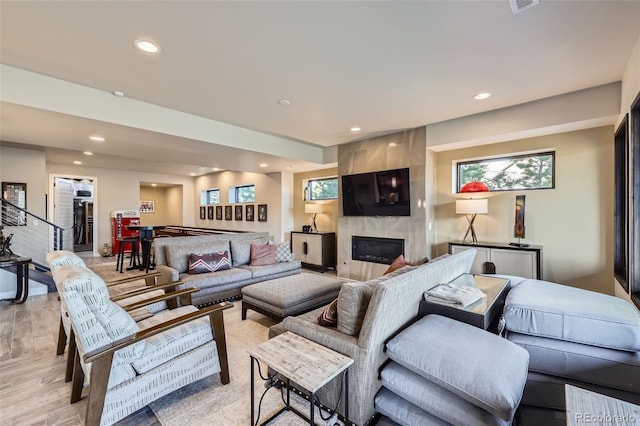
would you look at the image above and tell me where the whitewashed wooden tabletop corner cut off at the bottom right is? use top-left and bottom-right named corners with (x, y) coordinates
top-left (564, 385), bottom-right (640, 426)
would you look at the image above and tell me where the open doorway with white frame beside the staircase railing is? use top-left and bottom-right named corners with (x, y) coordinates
top-left (49, 175), bottom-right (99, 252)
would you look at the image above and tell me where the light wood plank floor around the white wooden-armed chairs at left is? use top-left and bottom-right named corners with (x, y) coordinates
top-left (0, 251), bottom-right (159, 426)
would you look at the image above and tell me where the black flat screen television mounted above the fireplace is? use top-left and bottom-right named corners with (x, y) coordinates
top-left (342, 168), bottom-right (411, 216)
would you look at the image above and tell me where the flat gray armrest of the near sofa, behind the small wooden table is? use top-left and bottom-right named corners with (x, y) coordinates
top-left (282, 317), bottom-right (362, 359)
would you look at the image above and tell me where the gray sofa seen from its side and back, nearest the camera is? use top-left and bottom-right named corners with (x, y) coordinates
top-left (269, 249), bottom-right (476, 425)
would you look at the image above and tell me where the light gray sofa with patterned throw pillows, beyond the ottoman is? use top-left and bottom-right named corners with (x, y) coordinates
top-left (153, 232), bottom-right (302, 306)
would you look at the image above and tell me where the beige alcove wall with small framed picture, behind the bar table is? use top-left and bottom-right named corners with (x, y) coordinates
top-left (140, 185), bottom-right (183, 225)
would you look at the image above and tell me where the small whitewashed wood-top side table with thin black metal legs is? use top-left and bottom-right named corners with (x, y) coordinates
top-left (249, 331), bottom-right (353, 426)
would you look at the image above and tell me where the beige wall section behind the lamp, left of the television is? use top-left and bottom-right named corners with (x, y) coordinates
top-left (293, 167), bottom-right (339, 232)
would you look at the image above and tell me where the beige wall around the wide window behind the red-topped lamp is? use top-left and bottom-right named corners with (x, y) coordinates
top-left (436, 126), bottom-right (613, 294)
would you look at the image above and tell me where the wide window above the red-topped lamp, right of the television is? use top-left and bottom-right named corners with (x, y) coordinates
top-left (456, 152), bottom-right (555, 192)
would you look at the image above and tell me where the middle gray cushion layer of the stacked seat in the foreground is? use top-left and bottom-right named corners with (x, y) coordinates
top-left (380, 362), bottom-right (511, 426)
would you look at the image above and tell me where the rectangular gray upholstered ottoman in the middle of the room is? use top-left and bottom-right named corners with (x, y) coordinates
top-left (242, 273), bottom-right (343, 320)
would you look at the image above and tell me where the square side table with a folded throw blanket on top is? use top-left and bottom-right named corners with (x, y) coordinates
top-left (418, 274), bottom-right (509, 330)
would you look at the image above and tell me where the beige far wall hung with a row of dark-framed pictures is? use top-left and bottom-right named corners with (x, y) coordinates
top-left (193, 171), bottom-right (293, 242)
